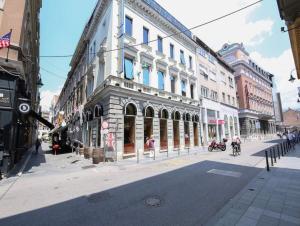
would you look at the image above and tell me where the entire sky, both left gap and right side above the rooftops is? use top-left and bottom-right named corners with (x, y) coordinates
top-left (40, 0), bottom-right (300, 109)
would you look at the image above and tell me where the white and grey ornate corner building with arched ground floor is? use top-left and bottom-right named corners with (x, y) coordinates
top-left (56, 0), bottom-right (201, 159)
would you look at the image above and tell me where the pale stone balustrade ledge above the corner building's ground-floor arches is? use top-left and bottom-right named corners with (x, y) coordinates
top-left (92, 75), bottom-right (200, 106)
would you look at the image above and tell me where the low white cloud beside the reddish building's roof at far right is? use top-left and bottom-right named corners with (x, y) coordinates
top-left (250, 49), bottom-right (300, 109)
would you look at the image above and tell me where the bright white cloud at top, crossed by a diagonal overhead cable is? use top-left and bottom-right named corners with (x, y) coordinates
top-left (157, 0), bottom-right (274, 51)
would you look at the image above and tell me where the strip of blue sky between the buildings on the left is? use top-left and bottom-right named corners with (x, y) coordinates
top-left (40, 0), bottom-right (97, 91)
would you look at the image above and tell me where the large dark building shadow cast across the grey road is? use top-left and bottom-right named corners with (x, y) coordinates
top-left (0, 161), bottom-right (261, 226)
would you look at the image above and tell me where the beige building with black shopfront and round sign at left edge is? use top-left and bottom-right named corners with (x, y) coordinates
top-left (0, 0), bottom-right (42, 171)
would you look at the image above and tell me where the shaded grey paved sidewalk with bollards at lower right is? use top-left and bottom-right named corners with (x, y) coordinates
top-left (207, 145), bottom-right (300, 226)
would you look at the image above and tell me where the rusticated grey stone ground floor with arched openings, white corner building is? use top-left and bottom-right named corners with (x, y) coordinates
top-left (82, 89), bottom-right (202, 158)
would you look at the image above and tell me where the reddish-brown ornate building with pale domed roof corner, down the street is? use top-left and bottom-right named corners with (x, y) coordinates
top-left (218, 43), bottom-right (276, 137)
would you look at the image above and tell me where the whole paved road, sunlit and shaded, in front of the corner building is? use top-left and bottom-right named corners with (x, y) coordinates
top-left (0, 141), bottom-right (284, 226)
